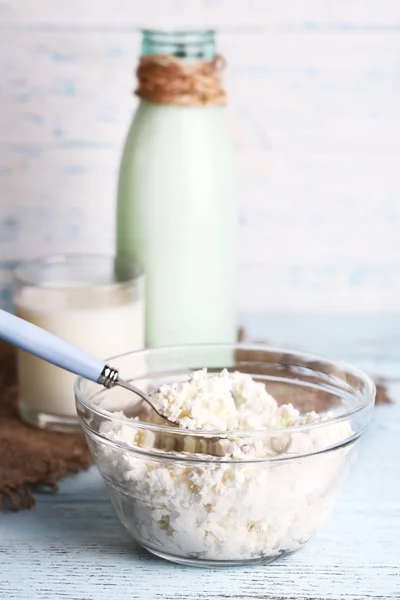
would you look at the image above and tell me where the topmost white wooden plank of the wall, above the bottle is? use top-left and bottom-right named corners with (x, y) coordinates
top-left (0, 0), bottom-right (400, 30)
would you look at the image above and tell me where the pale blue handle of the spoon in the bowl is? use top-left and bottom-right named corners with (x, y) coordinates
top-left (0, 310), bottom-right (105, 382)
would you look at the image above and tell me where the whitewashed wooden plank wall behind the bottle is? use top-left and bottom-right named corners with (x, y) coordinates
top-left (0, 0), bottom-right (400, 313)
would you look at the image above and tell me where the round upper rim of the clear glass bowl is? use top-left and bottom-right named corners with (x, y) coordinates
top-left (74, 342), bottom-right (376, 436)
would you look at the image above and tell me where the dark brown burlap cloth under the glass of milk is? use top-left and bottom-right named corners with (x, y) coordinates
top-left (0, 331), bottom-right (391, 510)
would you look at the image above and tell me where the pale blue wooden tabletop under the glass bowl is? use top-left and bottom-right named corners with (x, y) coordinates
top-left (0, 316), bottom-right (400, 600)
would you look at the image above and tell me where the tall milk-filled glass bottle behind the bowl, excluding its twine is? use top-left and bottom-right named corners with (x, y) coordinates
top-left (117, 30), bottom-right (237, 347)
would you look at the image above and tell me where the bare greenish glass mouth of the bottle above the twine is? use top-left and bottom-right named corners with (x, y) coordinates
top-left (142, 29), bottom-right (216, 61)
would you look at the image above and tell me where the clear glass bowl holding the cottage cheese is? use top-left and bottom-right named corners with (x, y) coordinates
top-left (75, 344), bottom-right (375, 567)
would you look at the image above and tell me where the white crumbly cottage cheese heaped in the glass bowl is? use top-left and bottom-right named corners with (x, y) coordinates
top-left (95, 370), bottom-right (351, 561)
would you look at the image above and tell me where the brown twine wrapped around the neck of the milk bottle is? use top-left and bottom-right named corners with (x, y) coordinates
top-left (135, 55), bottom-right (226, 106)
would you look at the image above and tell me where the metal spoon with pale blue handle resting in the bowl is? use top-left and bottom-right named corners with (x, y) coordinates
top-left (0, 309), bottom-right (177, 427)
